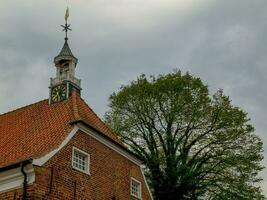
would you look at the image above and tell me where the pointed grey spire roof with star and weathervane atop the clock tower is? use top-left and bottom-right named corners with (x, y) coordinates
top-left (54, 7), bottom-right (78, 64)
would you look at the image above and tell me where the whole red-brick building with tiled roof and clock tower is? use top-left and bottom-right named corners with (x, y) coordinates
top-left (0, 12), bottom-right (152, 200)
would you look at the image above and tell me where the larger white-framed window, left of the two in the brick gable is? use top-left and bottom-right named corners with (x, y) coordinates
top-left (72, 147), bottom-right (90, 174)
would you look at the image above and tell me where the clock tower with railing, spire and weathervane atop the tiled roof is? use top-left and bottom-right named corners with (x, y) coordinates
top-left (49, 8), bottom-right (81, 104)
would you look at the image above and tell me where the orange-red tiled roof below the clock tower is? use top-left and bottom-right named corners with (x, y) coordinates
top-left (0, 92), bottom-right (123, 167)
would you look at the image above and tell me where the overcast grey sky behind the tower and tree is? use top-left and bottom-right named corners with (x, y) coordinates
top-left (0, 0), bottom-right (267, 195)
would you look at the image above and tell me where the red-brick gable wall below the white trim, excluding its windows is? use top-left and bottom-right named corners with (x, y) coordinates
top-left (34, 131), bottom-right (150, 200)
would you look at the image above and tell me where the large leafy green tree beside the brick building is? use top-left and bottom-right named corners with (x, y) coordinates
top-left (105, 71), bottom-right (264, 200)
